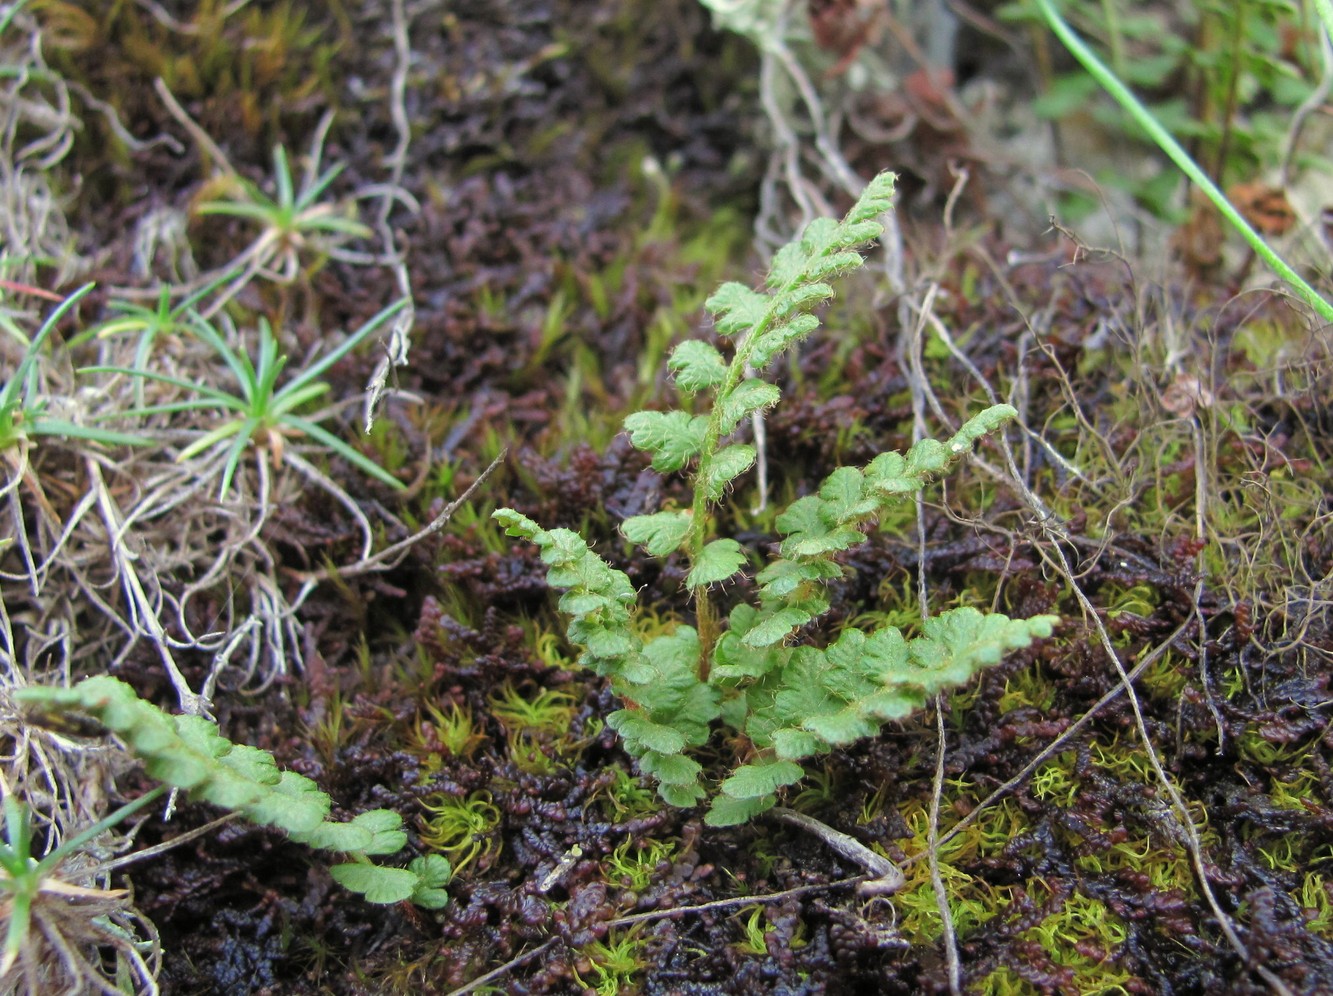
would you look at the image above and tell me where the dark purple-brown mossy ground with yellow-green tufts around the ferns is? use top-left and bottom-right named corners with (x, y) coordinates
top-left (10, 0), bottom-right (1333, 993)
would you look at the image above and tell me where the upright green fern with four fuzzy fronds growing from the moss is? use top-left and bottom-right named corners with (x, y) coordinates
top-left (495, 173), bottom-right (1057, 825)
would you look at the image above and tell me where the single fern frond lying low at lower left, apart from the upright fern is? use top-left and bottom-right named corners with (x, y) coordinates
top-left (13, 675), bottom-right (453, 909)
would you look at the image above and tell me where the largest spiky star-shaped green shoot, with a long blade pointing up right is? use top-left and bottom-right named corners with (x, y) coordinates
top-left (88, 299), bottom-right (407, 497)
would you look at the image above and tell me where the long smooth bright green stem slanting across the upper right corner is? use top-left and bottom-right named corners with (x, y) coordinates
top-left (1033, 0), bottom-right (1333, 323)
